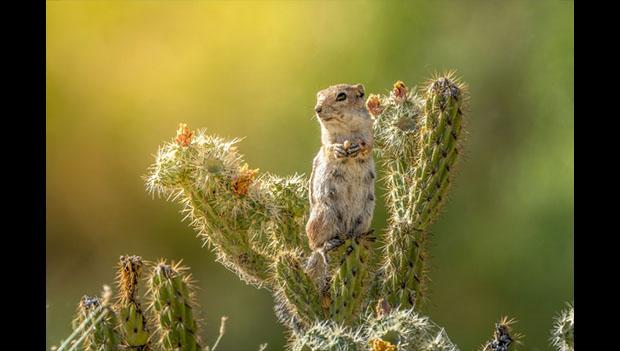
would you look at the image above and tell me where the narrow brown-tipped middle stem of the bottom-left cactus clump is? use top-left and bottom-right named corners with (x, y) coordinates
top-left (117, 256), bottom-right (150, 351)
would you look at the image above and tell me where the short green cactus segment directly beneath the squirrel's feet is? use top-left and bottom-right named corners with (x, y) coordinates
top-left (330, 238), bottom-right (371, 325)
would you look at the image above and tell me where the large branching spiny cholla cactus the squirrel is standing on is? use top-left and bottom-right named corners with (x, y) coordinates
top-left (146, 73), bottom-right (466, 350)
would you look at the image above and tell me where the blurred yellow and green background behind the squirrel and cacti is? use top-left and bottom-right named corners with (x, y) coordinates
top-left (46, 0), bottom-right (574, 350)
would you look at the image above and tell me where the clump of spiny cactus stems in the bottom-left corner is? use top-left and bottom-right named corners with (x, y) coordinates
top-left (53, 256), bottom-right (226, 351)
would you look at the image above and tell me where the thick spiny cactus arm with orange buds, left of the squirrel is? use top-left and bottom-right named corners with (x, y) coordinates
top-left (146, 130), bottom-right (309, 286)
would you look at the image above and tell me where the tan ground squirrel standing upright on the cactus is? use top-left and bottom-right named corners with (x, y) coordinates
top-left (306, 84), bottom-right (375, 278)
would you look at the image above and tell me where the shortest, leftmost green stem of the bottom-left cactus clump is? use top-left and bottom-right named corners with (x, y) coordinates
top-left (76, 296), bottom-right (120, 351)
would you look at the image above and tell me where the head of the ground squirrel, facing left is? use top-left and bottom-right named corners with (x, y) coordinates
top-left (314, 84), bottom-right (372, 129)
